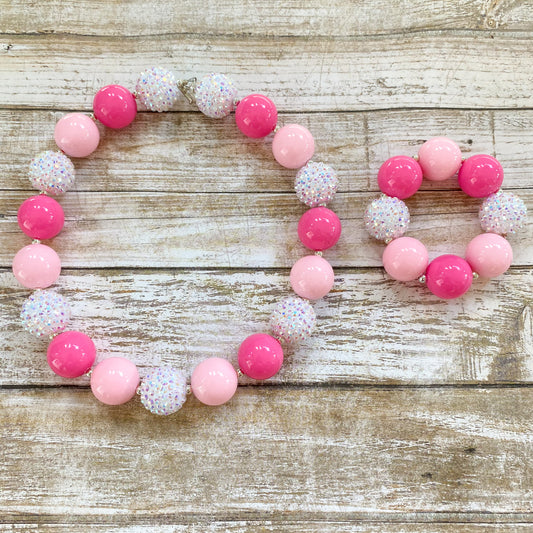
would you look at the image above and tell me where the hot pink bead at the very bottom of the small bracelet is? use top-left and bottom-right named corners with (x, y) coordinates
top-left (426, 254), bottom-right (472, 299)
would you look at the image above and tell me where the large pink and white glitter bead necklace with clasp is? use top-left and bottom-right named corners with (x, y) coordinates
top-left (13, 68), bottom-right (341, 415)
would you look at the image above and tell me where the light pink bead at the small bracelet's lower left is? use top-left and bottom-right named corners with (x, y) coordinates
top-left (383, 237), bottom-right (428, 281)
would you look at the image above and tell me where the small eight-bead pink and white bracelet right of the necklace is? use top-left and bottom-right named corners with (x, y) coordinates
top-left (364, 137), bottom-right (527, 299)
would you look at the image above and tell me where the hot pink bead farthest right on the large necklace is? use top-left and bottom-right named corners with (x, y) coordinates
top-left (298, 207), bottom-right (341, 251)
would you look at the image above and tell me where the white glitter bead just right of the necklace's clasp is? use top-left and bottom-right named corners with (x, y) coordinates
top-left (195, 74), bottom-right (237, 118)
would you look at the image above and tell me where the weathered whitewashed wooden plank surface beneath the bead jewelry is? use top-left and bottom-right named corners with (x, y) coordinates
top-left (0, 0), bottom-right (533, 533)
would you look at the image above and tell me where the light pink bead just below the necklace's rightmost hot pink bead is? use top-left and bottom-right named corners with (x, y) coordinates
top-left (290, 255), bottom-right (334, 300)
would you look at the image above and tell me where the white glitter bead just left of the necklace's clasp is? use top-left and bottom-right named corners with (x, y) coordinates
top-left (135, 67), bottom-right (180, 113)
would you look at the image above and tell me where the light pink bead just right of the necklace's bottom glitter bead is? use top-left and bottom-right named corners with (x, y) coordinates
top-left (191, 357), bottom-right (238, 405)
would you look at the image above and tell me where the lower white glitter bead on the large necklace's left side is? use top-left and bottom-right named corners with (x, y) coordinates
top-left (20, 290), bottom-right (70, 337)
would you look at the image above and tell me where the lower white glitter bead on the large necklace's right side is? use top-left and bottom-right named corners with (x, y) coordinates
top-left (270, 296), bottom-right (316, 344)
